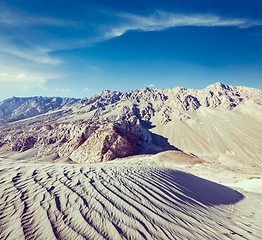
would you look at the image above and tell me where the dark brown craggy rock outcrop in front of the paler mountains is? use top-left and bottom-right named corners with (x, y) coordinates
top-left (0, 101), bottom-right (173, 163)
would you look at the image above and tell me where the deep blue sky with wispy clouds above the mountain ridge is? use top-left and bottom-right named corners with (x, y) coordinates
top-left (0, 0), bottom-right (262, 101)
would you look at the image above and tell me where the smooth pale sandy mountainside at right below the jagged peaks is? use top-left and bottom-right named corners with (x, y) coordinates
top-left (151, 102), bottom-right (262, 167)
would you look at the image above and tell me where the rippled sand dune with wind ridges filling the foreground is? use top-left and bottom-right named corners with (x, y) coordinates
top-left (0, 161), bottom-right (262, 239)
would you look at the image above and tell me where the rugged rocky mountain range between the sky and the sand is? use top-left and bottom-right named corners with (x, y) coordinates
top-left (0, 83), bottom-right (262, 166)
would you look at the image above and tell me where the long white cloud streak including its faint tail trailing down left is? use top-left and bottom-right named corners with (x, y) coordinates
top-left (40, 11), bottom-right (262, 52)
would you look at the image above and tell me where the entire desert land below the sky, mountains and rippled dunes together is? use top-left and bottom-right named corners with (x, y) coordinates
top-left (0, 83), bottom-right (262, 239)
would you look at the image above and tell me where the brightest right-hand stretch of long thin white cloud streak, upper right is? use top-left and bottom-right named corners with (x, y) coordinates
top-left (104, 11), bottom-right (262, 39)
